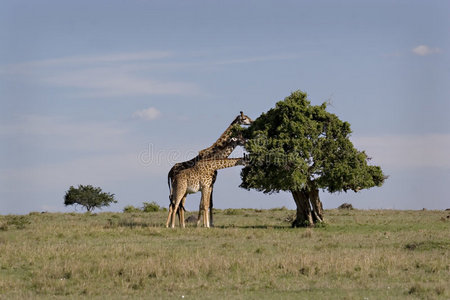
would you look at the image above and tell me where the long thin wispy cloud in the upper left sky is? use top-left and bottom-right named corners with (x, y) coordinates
top-left (0, 52), bottom-right (202, 98)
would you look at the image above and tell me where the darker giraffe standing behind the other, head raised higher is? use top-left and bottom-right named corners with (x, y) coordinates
top-left (167, 111), bottom-right (253, 224)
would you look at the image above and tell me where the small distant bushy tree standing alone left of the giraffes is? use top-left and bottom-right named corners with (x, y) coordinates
top-left (64, 184), bottom-right (117, 212)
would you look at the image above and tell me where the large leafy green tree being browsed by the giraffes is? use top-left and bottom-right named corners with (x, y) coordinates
top-left (241, 91), bottom-right (386, 227)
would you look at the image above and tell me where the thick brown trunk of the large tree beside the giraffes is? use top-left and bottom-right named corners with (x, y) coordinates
top-left (291, 189), bottom-right (323, 227)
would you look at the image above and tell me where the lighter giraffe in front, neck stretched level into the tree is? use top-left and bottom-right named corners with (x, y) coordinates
top-left (166, 157), bottom-right (245, 228)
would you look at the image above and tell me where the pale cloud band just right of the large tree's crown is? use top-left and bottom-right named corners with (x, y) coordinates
top-left (352, 134), bottom-right (450, 169)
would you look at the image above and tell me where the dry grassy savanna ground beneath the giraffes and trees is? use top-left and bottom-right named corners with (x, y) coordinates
top-left (0, 209), bottom-right (450, 299)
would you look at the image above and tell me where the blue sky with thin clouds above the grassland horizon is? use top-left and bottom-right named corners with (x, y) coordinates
top-left (0, 0), bottom-right (450, 214)
